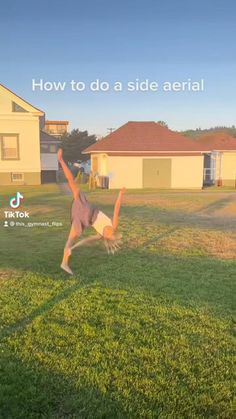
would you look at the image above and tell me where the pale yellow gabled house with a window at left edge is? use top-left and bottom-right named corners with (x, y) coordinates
top-left (0, 85), bottom-right (58, 185)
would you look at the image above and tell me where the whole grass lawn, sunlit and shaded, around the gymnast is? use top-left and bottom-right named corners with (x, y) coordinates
top-left (0, 185), bottom-right (236, 419)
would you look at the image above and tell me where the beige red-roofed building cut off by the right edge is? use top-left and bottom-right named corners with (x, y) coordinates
top-left (197, 132), bottom-right (236, 186)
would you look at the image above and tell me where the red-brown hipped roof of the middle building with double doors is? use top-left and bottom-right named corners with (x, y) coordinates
top-left (83, 121), bottom-right (201, 155)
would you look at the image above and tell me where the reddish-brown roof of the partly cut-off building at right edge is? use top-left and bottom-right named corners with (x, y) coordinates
top-left (197, 131), bottom-right (236, 151)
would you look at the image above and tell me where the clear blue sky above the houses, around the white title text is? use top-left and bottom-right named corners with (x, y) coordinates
top-left (0, 0), bottom-right (236, 135)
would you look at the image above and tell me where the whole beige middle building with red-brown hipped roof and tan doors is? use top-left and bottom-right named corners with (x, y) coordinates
top-left (83, 122), bottom-right (204, 189)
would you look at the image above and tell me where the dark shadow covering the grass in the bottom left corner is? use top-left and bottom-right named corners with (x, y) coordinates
top-left (0, 353), bottom-right (128, 419)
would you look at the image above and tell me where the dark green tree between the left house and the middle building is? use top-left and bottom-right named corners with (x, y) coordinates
top-left (61, 129), bottom-right (96, 163)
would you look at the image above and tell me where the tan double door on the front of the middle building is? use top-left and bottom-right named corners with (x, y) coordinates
top-left (143, 159), bottom-right (171, 188)
